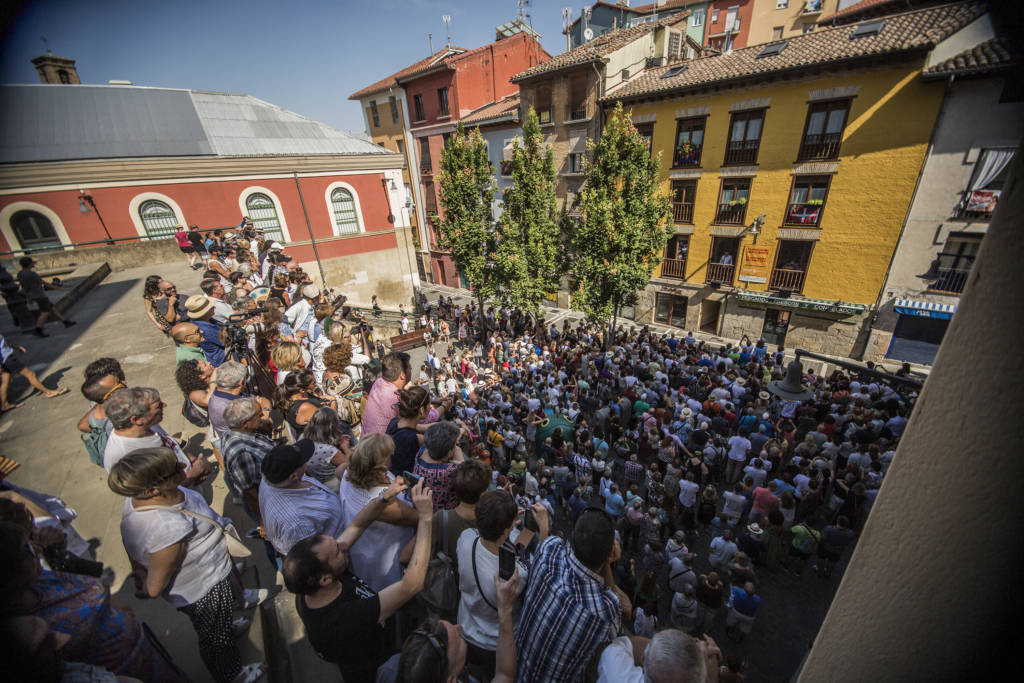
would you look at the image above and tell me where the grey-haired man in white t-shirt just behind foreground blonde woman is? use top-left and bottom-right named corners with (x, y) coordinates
top-left (103, 387), bottom-right (210, 486)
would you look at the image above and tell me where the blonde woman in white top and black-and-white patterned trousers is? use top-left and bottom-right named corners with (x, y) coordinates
top-left (106, 447), bottom-right (265, 683)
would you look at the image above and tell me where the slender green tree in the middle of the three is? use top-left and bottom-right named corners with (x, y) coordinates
top-left (497, 108), bottom-right (561, 315)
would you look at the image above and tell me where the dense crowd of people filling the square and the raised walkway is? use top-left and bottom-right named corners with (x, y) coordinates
top-left (0, 220), bottom-right (915, 683)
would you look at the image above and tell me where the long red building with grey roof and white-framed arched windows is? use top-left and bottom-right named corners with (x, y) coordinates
top-left (0, 85), bottom-right (419, 305)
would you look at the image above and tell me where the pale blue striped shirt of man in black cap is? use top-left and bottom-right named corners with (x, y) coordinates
top-left (259, 476), bottom-right (345, 555)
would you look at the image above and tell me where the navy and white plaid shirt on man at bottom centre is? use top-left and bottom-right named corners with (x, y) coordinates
top-left (515, 537), bottom-right (621, 683)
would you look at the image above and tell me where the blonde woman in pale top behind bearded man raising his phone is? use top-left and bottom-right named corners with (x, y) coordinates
top-left (338, 434), bottom-right (417, 592)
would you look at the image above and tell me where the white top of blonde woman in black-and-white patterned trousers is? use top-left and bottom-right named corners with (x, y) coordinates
top-left (121, 488), bottom-right (231, 607)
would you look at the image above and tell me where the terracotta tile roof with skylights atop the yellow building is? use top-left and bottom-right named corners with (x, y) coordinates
top-left (602, 0), bottom-right (985, 101)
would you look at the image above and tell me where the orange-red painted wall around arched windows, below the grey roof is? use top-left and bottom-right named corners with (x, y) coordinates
top-left (0, 171), bottom-right (399, 260)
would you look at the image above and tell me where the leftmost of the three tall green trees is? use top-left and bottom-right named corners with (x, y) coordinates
top-left (436, 123), bottom-right (500, 339)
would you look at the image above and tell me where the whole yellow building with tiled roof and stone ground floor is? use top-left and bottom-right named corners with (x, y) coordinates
top-left (602, 2), bottom-right (987, 356)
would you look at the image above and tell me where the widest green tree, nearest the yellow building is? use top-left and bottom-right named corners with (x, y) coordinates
top-left (563, 102), bottom-right (672, 343)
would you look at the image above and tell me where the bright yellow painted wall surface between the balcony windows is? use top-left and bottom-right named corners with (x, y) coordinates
top-left (631, 65), bottom-right (943, 304)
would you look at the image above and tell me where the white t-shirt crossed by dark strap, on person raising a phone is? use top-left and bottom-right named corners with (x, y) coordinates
top-left (456, 528), bottom-right (526, 650)
